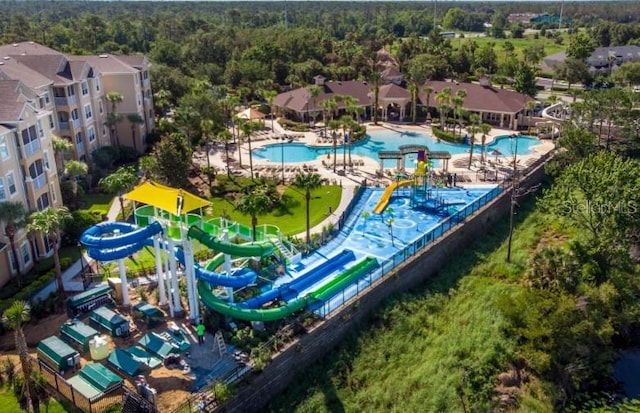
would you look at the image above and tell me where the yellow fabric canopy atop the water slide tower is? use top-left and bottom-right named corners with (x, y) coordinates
top-left (124, 182), bottom-right (210, 215)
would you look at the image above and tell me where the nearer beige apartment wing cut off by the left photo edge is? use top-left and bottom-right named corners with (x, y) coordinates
top-left (0, 79), bottom-right (62, 286)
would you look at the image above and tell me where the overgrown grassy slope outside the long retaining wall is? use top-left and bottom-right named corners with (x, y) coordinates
top-left (270, 192), bottom-right (551, 412)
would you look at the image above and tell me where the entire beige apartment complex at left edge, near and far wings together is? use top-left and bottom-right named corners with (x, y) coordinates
top-left (0, 42), bottom-right (154, 286)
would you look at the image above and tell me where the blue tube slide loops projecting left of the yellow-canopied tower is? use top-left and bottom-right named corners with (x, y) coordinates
top-left (80, 222), bottom-right (162, 261)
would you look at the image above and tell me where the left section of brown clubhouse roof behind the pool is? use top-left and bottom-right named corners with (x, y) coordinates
top-left (273, 80), bottom-right (371, 112)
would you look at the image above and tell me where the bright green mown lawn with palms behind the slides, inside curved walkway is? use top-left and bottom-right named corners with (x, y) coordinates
top-left (206, 185), bottom-right (342, 235)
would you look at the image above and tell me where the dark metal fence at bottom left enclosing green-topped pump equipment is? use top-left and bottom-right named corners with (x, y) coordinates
top-left (29, 357), bottom-right (157, 413)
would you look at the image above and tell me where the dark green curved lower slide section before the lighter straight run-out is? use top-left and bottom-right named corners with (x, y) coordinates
top-left (198, 280), bottom-right (307, 321)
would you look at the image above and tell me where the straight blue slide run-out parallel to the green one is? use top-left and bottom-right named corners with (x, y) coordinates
top-left (238, 250), bottom-right (356, 308)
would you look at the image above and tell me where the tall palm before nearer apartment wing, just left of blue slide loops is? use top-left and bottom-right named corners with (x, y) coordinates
top-left (27, 206), bottom-right (71, 299)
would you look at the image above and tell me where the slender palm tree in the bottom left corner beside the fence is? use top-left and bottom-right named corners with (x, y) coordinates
top-left (2, 301), bottom-right (34, 412)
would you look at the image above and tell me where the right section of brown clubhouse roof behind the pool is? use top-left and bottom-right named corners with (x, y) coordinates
top-left (418, 80), bottom-right (533, 113)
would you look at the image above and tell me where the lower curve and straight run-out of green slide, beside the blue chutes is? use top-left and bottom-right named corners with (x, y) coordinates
top-left (198, 257), bottom-right (378, 321)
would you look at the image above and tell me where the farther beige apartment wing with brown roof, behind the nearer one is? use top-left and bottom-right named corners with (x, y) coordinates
top-left (0, 42), bottom-right (154, 158)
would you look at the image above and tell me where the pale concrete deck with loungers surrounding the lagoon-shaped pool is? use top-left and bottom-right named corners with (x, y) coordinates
top-left (200, 120), bottom-right (554, 236)
